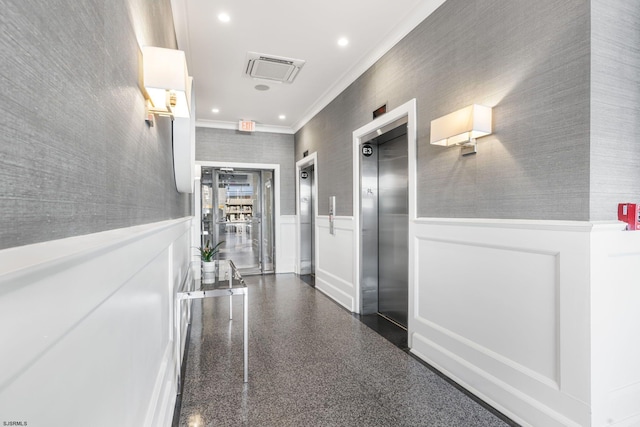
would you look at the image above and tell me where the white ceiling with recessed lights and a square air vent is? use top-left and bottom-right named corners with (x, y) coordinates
top-left (171, 0), bottom-right (444, 133)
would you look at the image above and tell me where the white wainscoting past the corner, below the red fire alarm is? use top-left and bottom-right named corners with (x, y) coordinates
top-left (591, 227), bottom-right (640, 427)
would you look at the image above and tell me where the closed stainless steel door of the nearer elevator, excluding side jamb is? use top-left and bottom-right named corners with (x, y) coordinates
top-left (378, 127), bottom-right (409, 327)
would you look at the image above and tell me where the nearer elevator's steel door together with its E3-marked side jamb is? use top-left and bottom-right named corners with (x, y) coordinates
top-left (360, 121), bottom-right (409, 329)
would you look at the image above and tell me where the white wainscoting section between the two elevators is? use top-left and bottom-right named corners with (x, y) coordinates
top-left (316, 216), bottom-right (358, 312)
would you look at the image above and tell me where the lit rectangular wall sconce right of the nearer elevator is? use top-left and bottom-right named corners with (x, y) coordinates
top-left (431, 104), bottom-right (492, 156)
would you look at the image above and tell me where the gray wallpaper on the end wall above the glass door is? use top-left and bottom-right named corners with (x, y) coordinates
top-left (196, 127), bottom-right (296, 215)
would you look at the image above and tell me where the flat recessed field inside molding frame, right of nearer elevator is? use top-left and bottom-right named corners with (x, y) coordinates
top-left (416, 238), bottom-right (558, 385)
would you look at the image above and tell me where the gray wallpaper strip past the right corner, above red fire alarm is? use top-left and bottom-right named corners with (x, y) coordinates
top-left (590, 0), bottom-right (640, 219)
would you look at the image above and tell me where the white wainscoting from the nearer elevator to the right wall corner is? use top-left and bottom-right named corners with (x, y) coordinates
top-left (409, 219), bottom-right (591, 426)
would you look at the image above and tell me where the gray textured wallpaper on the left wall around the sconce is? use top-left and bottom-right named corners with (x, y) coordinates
top-left (0, 0), bottom-right (191, 249)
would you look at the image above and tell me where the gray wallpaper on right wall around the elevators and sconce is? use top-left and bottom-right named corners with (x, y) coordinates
top-left (296, 0), bottom-right (596, 220)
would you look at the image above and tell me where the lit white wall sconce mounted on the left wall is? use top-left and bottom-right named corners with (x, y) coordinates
top-left (142, 46), bottom-right (191, 118)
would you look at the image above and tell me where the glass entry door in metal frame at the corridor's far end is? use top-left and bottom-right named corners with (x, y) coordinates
top-left (202, 167), bottom-right (275, 275)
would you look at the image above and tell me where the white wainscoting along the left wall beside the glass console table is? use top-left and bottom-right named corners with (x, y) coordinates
top-left (0, 218), bottom-right (192, 427)
